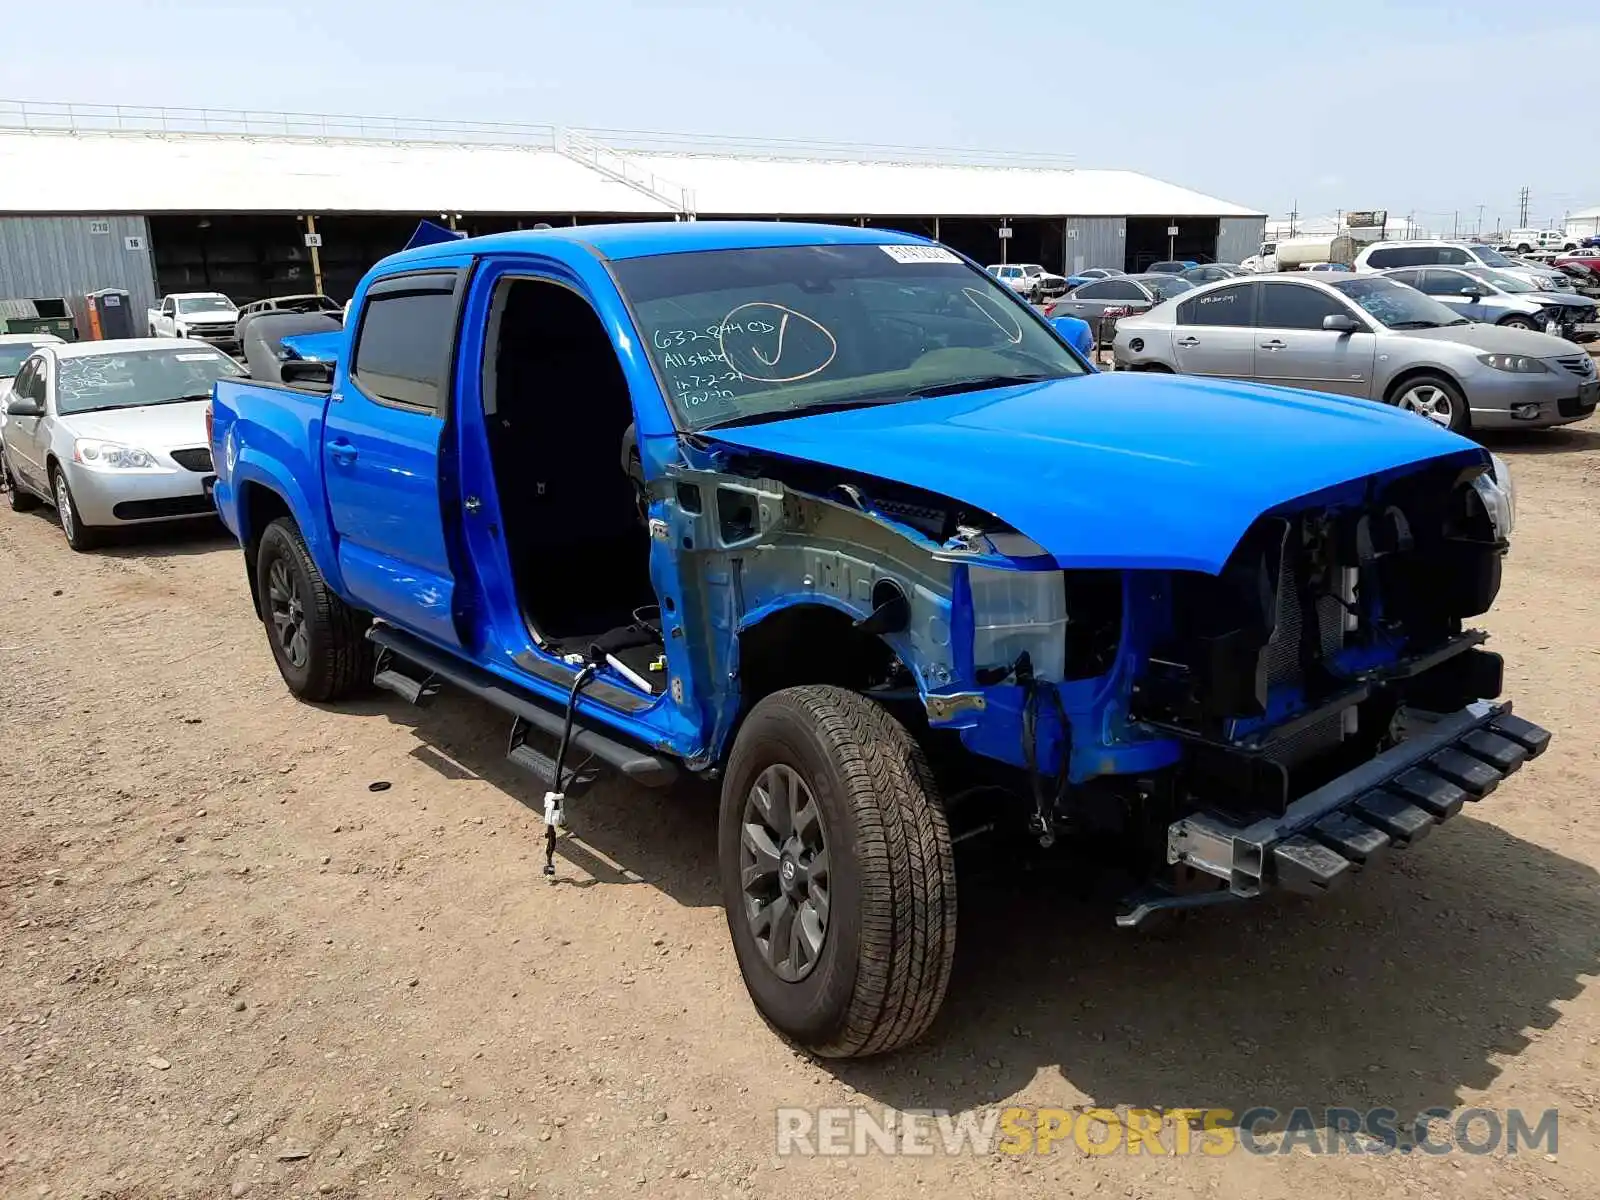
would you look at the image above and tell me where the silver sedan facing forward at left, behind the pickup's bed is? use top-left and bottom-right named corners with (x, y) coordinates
top-left (0, 338), bottom-right (245, 550)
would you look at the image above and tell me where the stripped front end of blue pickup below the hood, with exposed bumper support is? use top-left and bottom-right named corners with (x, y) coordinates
top-left (651, 435), bottom-right (1549, 925)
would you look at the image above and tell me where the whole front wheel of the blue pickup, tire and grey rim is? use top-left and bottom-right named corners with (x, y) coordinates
top-left (718, 686), bottom-right (955, 1058)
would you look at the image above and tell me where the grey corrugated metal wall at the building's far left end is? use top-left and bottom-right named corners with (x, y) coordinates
top-left (0, 216), bottom-right (158, 334)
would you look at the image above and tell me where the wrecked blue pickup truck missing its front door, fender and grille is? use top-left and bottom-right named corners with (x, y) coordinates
top-left (210, 222), bottom-right (1549, 1056)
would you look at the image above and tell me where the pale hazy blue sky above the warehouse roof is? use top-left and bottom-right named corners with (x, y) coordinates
top-left (0, 0), bottom-right (1600, 232)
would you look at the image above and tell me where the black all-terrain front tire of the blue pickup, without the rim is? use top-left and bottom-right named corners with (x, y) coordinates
top-left (718, 686), bottom-right (955, 1058)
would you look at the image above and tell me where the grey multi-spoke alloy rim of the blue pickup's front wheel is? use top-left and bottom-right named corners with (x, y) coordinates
top-left (739, 763), bottom-right (829, 984)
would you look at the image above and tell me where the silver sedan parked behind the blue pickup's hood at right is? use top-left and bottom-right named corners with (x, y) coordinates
top-left (1114, 272), bottom-right (1600, 430)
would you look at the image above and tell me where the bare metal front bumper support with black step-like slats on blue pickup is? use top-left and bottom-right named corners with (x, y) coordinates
top-left (1166, 701), bottom-right (1550, 898)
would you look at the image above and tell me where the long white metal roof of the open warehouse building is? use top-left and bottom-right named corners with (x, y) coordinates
top-left (0, 101), bottom-right (1264, 218)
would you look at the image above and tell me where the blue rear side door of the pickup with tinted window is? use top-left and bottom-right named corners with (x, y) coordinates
top-left (322, 267), bottom-right (466, 645)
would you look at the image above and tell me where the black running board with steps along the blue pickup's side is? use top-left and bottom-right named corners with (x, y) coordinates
top-left (366, 622), bottom-right (678, 787)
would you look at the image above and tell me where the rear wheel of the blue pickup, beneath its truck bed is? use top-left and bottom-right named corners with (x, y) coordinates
top-left (256, 517), bottom-right (371, 702)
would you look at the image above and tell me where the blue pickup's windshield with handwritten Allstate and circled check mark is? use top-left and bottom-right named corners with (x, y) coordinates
top-left (613, 245), bottom-right (1088, 430)
